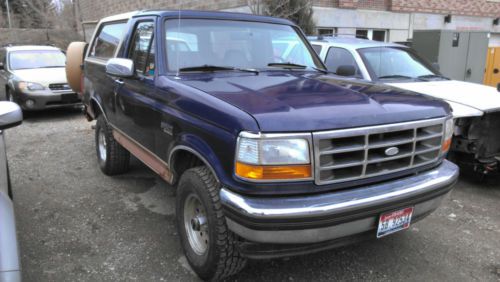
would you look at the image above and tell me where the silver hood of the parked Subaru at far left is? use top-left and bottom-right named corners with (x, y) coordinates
top-left (12, 67), bottom-right (67, 87)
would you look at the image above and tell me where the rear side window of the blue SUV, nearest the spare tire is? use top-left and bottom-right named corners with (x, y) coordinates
top-left (90, 22), bottom-right (126, 59)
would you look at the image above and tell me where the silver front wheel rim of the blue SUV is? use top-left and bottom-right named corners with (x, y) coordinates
top-left (184, 194), bottom-right (210, 255)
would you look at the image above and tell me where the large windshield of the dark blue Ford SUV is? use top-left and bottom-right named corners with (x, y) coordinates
top-left (165, 19), bottom-right (324, 72)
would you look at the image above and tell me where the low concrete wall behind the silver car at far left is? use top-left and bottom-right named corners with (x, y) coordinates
top-left (0, 28), bottom-right (82, 49)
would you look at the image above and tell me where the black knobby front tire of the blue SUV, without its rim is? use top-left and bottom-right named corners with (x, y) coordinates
top-left (176, 166), bottom-right (246, 281)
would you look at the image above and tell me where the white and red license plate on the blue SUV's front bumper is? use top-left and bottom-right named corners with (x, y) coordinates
top-left (377, 207), bottom-right (413, 238)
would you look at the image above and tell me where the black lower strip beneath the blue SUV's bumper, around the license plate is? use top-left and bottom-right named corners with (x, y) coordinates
top-left (238, 210), bottom-right (434, 259)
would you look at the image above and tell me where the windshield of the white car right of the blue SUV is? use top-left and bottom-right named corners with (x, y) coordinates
top-left (358, 47), bottom-right (439, 80)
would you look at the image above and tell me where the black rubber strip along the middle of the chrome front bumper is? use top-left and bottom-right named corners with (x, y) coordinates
top-left (224, 180), bottom-right (457, 231)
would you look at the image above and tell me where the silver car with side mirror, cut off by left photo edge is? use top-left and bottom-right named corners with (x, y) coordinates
top-left (0, 102), bottom-right (23, 282)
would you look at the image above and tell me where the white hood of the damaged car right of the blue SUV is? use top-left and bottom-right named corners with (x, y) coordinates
top-left (389, 80), bottom-right (500, 117)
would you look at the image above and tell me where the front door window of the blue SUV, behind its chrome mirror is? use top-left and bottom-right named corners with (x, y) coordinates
top-left (128, 22), bottom-right (155, 76)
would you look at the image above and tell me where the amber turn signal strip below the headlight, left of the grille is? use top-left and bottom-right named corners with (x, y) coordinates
top-left (235, 162), bottom-right (312, 180)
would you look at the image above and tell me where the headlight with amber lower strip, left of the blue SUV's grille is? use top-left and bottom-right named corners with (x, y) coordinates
top-left (235, 132), bottom-right (312, 181)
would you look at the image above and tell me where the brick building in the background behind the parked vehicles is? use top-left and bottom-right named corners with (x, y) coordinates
top-left (76, 0), bottom-right (500, 46)
